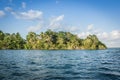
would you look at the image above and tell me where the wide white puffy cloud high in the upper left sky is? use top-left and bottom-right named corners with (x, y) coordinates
top-left (12, 9), bottom-right (43, 20)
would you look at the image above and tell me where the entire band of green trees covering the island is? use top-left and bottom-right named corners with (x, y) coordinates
top-left (0, 30), bottom-right (107, 49)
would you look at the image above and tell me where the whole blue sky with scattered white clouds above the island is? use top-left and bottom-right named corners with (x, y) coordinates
top-left (0, 0), bottom-right (120, 47)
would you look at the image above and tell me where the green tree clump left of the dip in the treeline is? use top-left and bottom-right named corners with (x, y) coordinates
top-left (0, 33), bottom-right (25, 49)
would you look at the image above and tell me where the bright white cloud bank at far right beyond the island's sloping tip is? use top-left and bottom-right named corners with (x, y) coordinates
top-left (97, 30), bottom-right (120, 47)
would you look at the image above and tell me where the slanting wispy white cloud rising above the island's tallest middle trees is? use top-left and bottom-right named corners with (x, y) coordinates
top-left (49, 15), bottom-right (64, 30)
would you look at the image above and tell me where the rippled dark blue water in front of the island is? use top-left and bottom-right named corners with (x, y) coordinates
top-left (0, 48), bottom-right (120, 80)
